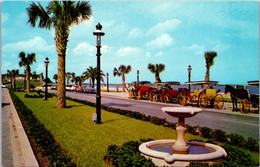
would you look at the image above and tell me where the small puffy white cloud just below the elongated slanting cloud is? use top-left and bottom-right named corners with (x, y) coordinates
top-left (146, 34), bottom-right (174, 48)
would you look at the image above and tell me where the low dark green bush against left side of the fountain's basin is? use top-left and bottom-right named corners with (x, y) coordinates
top-left (105, 140), bottom-right (155, 167)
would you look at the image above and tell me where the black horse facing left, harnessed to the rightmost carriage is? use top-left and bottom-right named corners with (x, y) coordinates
top-left (225, 85), bottom-right (249, 111)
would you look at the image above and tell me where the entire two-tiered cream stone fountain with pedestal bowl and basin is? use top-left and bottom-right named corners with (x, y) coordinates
top-left (139, 107), bottom-right (227, 166)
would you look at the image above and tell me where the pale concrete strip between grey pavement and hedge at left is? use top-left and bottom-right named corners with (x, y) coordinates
top-left (7, 91), bottom-right (39, 167)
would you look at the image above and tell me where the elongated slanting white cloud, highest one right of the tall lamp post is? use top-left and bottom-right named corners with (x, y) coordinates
top-left (146, 19), bottom-right (181, 36)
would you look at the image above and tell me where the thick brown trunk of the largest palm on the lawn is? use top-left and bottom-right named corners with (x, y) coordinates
top-left (55, 27), bottom-right (69, 108)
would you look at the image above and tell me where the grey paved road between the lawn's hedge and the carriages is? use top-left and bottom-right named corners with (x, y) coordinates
top-left (48, 91), bottom-right (259, 138)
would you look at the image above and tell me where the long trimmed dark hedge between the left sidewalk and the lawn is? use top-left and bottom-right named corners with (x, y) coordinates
top-left (10, 91), bottom-right (76, 166)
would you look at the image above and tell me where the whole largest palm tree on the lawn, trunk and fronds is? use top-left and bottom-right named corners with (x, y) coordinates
top-left (27, 1), bottom-right (92, 108)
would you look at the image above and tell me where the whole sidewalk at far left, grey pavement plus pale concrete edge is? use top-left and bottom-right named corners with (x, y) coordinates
top-left (2, 88), bottom-right (39, 167)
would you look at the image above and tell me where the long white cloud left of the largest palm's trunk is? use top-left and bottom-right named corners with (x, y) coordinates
top-left (2, 36), bottom-right (55, 53)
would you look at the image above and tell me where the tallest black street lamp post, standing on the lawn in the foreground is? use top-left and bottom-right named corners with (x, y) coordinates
top-left (93, 23), bottom-right (105, 124)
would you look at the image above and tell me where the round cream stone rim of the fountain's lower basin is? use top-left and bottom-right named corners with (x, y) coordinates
top-left (139, 140), bottom-right (227, 165)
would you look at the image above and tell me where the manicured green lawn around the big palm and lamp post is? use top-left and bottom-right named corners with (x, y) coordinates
top-left (16, 92), bottom-right (204, 166)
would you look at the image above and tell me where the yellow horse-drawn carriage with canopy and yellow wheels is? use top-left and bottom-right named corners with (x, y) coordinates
top-left (181, 81), bottom-right (224, 109)
